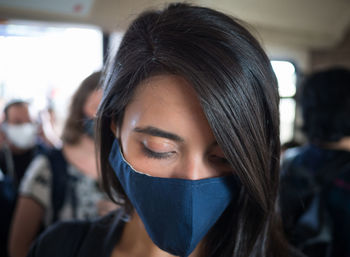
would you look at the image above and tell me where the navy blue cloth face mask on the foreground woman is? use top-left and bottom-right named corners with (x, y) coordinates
top-left (109, 140), bottom-right (239, 256)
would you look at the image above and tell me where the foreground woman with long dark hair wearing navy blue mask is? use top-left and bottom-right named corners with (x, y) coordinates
top-left (26, 4), bottom-right (295, 257)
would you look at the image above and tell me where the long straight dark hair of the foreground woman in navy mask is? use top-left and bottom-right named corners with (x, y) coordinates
top-left (96, 3), bottom-right (288, 257)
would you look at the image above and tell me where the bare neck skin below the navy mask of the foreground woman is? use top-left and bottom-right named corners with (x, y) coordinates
top-left (111, 211), bottom-right (199, 257)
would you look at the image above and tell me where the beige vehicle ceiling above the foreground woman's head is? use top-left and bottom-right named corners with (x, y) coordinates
top-left (0, 0), bottom-right (350, 49)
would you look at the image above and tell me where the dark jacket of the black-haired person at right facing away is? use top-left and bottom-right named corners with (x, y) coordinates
top-left (280, 145), bottom-right (350, 257)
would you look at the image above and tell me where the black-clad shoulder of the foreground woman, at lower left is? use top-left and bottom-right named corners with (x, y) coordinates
top-left (28, 210), bottom-right (126, 257)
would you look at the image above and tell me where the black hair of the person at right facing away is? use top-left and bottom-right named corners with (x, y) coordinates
top-left (298, 68), bottom-right (350, 144)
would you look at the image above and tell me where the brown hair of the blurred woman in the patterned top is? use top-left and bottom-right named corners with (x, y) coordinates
top-left (62, 72), bottom-right (101, 145)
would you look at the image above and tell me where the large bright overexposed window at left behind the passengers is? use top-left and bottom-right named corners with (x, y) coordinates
top-left (0, 21), bottom-right (103, 128)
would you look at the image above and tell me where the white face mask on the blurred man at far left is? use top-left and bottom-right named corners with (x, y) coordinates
top-left (4, 122), bottom-right (38, 149)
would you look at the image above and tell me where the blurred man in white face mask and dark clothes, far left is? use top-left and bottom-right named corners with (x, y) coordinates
top-left (0, 99), bottom-right (46, 256)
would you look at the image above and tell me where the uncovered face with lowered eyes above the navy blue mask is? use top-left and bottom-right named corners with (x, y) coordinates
top-left (117, 75), bottom-right (232, 180)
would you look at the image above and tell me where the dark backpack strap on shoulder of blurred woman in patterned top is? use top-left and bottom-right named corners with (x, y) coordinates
top-left (46, 149), bottom-right (68, 223)
